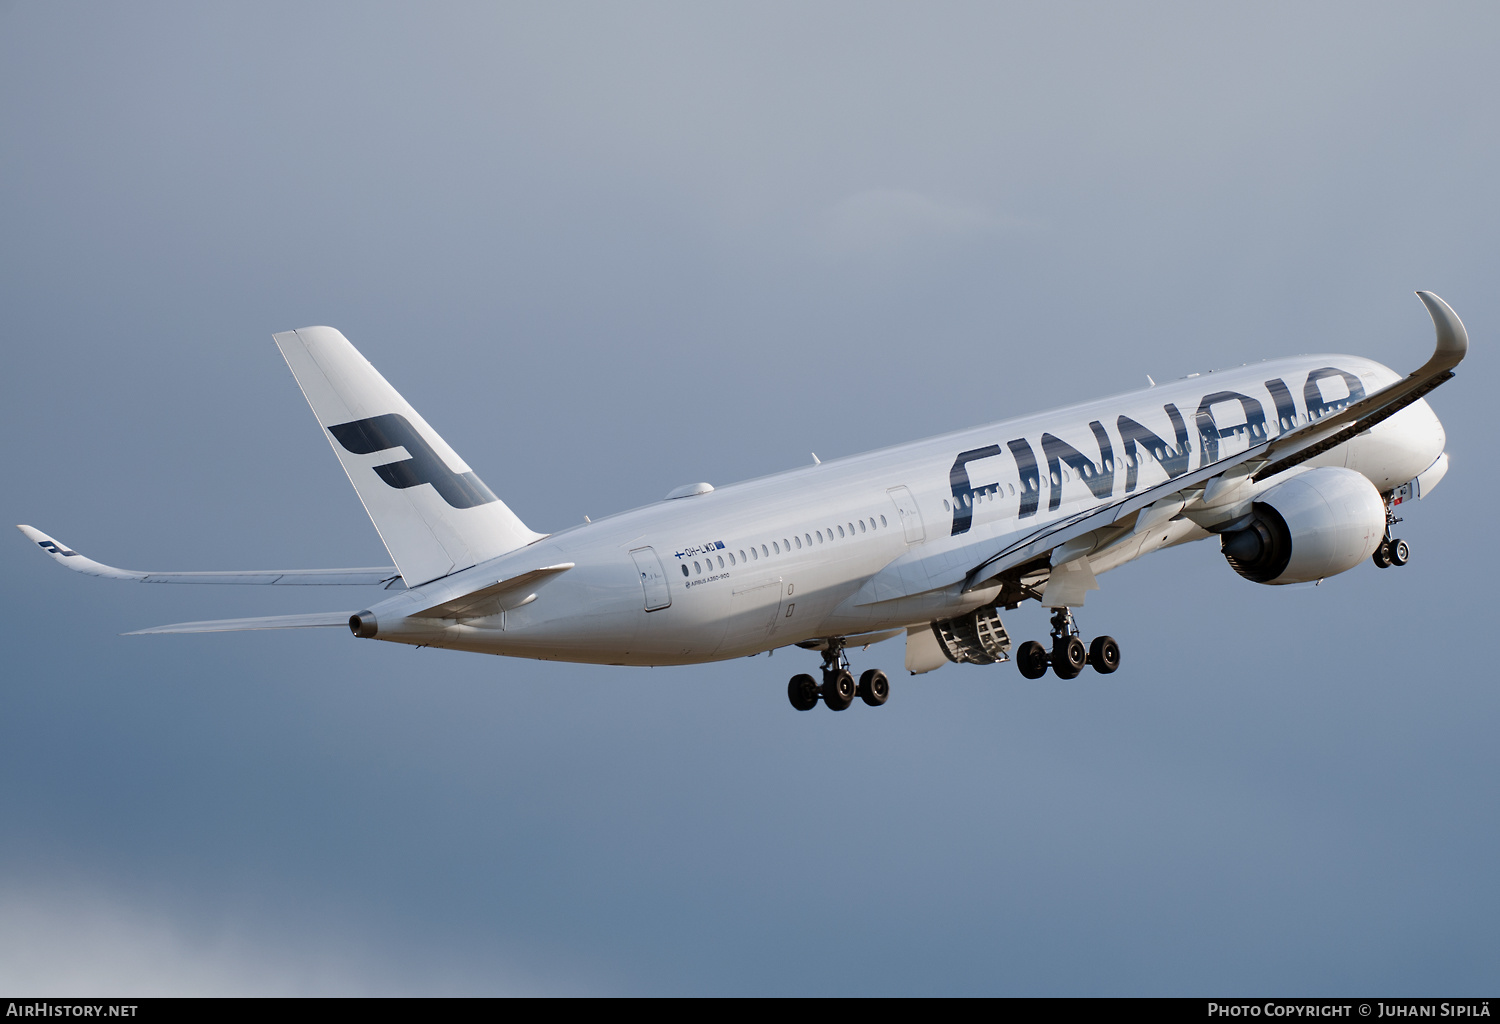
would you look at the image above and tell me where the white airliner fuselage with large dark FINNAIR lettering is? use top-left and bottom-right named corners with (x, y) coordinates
top-left (360, 355), bottom-right (1446, 664)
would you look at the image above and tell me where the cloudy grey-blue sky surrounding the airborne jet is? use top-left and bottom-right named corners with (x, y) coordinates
top-left (0, 3), bottom-right (1500, 996)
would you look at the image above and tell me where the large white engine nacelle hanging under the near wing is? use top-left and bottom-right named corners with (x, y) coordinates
top-left (1223, 466), bottom-right (1386, 583)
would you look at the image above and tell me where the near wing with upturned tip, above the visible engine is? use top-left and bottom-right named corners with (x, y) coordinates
top-left (855, 291), bottom-right (1469, 604)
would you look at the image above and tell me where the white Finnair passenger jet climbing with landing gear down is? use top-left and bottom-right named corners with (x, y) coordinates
top-left (20, 292), bottom-right (1469, 711)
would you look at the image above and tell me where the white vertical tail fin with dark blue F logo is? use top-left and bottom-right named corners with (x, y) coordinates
top-left (275, 327), bottom-right (543, 586)
